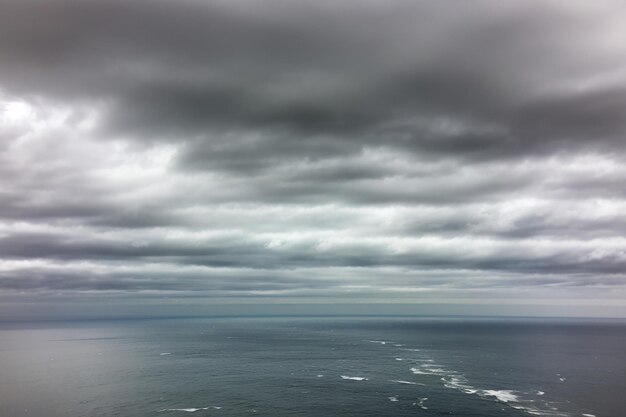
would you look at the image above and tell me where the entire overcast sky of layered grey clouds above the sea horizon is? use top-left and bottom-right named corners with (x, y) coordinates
top-left (0, 0), bottom-right (626, 319)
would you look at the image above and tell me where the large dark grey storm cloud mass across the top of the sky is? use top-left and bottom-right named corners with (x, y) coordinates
top-left (0, 1), bottom-right (626, 167)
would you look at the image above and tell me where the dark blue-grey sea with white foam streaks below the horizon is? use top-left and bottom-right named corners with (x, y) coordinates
top-left (0, 317), bottom-right (626, 417)
